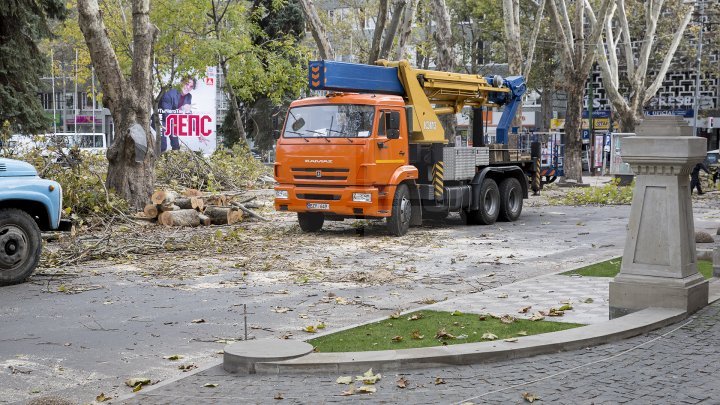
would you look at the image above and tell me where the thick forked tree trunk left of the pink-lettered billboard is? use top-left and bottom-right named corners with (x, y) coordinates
top-left (78, 0), bottom-right (158, 208)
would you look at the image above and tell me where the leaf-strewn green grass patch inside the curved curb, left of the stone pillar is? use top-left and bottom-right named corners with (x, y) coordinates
top-left (308, 310), bottom-right (584, 353)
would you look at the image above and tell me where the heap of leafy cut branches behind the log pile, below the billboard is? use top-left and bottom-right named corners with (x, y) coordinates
top-left (155, 145), bottom-right (268, 191)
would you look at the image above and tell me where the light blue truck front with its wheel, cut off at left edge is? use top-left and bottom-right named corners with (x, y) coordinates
top-left (0, 158), bottom-right (67, 286)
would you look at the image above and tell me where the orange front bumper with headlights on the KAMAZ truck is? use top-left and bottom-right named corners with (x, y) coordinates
top-left (275, 184), bottom-right (395, 218)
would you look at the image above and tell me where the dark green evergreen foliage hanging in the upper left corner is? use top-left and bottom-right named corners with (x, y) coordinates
top-left (0, 0), bottom-right (65, 133)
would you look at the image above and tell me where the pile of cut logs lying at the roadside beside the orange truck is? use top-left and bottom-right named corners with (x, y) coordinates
top-left (138, 189), bottom-right (266, 226)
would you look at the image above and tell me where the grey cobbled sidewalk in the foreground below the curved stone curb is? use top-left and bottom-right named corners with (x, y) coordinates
top-left (123, 302), bottom-right (720, 405)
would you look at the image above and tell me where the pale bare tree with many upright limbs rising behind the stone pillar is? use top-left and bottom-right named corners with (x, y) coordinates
top-left (597, 0), bottom-right (693, 132)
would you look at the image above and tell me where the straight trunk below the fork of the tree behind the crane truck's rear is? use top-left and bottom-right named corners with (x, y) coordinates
top-left (565, 75), bottom-right (586, 183)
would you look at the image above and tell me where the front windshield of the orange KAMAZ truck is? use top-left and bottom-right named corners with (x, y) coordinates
top-left (284, 104), bottom-right (375, 138)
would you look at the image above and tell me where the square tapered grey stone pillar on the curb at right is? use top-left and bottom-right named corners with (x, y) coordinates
top-left (610, 117), bottom-right (708, 319)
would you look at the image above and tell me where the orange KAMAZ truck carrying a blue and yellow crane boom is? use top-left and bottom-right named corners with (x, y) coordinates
top-left (274, 60), bottom-right (562, 236)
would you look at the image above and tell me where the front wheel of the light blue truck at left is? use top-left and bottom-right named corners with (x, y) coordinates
top-left (0, 208), bottom-right (42, 285)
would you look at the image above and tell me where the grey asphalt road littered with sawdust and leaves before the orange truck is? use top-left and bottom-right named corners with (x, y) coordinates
top-left (0, 193), bottom-right (720, 403)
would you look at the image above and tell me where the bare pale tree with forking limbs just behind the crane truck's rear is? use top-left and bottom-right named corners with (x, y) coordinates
top-left (548, 0), bottom-right (613, 183)
